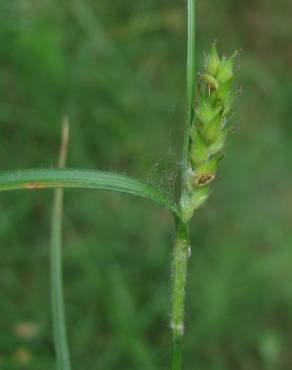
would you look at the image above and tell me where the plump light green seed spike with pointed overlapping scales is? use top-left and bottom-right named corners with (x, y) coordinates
top-left (181, 43), bottom-right (237, 222)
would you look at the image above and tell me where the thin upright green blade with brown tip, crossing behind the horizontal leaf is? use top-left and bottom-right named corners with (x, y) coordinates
top-left (51, 119), bottom-right (71, 370)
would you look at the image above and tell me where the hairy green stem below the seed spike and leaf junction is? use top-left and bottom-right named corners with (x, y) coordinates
top-left (171, 219), bottom-right (190, 370)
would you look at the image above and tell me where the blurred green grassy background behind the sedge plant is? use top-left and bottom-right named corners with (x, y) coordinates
top-left (0, 0), bottom-right (292, 370)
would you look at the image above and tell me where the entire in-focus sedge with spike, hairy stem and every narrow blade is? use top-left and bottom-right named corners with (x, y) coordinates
top-left (0, 0), bottom-right (235, 370)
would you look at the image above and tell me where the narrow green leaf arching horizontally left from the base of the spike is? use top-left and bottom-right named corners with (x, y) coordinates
top-left (0, 169), bottom-right (180, 218)
